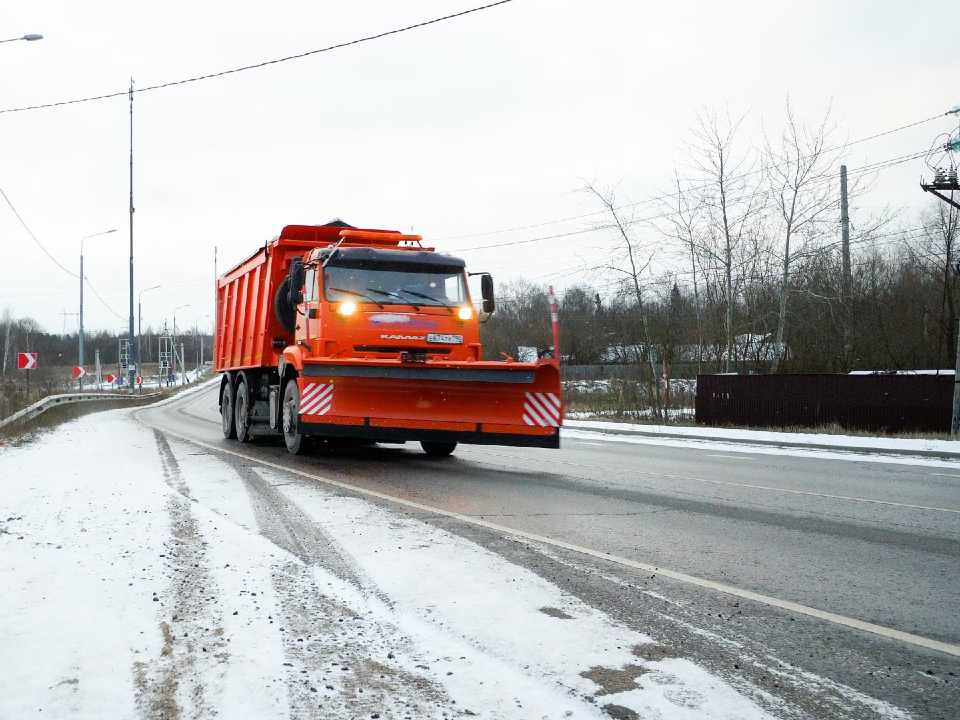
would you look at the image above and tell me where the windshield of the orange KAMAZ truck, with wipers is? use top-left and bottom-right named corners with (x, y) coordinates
top-left (323, 261), bottom-right (467, 307)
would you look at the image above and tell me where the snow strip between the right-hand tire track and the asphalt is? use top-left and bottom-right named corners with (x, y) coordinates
top-left (280, 473), bottom-right (765, 718)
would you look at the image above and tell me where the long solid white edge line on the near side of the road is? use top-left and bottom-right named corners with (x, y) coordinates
top-left (136, 410), bottom-right (960, 657)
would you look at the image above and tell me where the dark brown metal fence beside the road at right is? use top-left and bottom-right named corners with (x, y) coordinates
top-left (696, 375), bottom-right (954, 432)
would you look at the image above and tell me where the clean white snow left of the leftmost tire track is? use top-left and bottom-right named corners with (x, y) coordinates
top-left (0, 411), bottom-right (168, 718)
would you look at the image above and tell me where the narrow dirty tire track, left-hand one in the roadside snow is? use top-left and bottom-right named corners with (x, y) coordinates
top-left (133, 430), bottom-right (229, 720)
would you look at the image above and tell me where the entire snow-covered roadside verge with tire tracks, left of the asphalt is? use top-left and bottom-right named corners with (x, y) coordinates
top-left (0, 410), bottom-right (763, 718)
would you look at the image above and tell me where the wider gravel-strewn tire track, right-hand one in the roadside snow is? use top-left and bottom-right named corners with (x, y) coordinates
top-left (159, 446), bottom-right (457, 718)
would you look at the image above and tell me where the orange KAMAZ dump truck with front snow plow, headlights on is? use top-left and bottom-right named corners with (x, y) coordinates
top-left (214, 223), bottom-right (563, 455)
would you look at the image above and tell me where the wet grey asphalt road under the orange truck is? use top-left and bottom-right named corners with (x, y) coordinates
top-left (140, 382), bottom-right (960, 717)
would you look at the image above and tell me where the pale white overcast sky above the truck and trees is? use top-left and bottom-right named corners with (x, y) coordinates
top-left (0, 0), bottom-right (960, 332)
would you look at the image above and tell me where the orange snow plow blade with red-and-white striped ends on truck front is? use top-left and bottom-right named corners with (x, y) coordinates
top-left (298, 360), bottom-right (563, 448)
